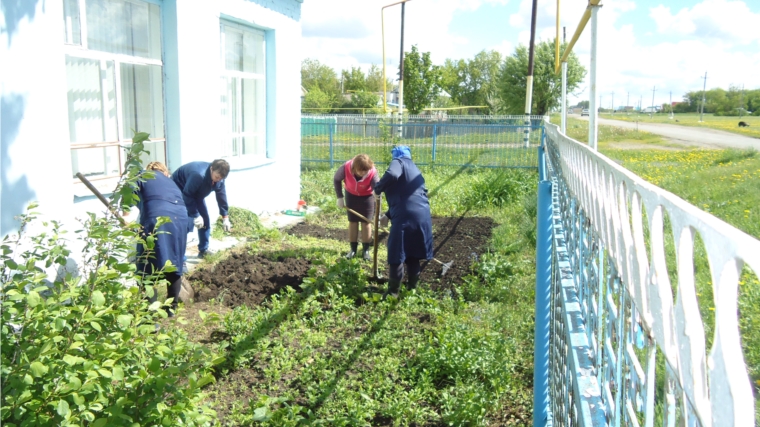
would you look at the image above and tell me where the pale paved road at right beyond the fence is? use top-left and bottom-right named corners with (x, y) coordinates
top-left (581, 117), bottom-right (760, 149)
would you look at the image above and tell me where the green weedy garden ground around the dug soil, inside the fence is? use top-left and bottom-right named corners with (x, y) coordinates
top-left (191, 168), bottom-right (537, 426)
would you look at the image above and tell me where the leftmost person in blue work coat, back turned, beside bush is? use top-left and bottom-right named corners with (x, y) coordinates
top-left (137, 162), bottom-right (190, 317)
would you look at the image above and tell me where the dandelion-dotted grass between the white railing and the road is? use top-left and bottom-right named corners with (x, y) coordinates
top-left (602, 145), bottom-right (760, 425)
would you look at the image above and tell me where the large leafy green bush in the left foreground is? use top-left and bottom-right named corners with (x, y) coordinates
top-left (0, 133), bottom-right (223, 427)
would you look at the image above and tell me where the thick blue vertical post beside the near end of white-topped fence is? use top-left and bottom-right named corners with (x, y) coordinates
top-left (533, 146), bottom-right (552, 427)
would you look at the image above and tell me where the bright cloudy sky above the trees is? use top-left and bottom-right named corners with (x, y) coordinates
top-left (301, 0), bottom-right (760, 108)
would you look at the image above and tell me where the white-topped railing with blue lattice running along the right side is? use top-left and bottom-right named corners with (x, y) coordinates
top-left (534, 124), bottom-right (760, 427)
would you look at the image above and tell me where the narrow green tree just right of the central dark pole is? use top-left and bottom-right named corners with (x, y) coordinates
top-left (404, 45), bottom-right (441, 114)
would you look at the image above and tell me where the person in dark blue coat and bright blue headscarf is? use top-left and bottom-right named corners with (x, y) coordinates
top-left (374, 145), bottom-right (433, 296)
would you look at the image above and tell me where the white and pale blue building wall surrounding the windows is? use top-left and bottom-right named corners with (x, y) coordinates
top-left (0, 0), bottom-right (301, 237)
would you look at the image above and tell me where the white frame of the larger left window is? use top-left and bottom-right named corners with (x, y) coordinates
top-left (63, 0), bottom-right (167, 189)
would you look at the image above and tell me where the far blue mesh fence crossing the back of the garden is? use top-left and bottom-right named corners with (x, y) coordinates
top-left (301, 117), bottom-right (543, 168)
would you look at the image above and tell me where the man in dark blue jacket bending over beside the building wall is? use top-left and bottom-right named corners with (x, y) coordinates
top-left (172, 159), bottom-right (232, 258)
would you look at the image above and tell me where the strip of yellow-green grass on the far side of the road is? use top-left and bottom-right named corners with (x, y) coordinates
top-left (600, 112), bottom-right (760, 143)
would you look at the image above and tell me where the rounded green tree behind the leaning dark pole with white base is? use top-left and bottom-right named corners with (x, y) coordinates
top-left (498, 41), bottom-right (586, 115)
